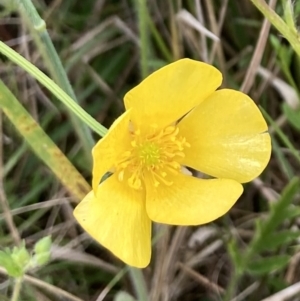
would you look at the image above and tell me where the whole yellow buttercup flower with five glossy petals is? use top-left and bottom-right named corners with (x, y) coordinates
top-left (74, 59), bottom-right (271, 267)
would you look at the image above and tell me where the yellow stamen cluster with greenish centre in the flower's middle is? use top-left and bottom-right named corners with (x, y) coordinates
top-left (116, 125), bottom-right (190, 190)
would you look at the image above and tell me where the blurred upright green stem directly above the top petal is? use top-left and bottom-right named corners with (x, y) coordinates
top-left (135, 0), bottom-right (150, 79)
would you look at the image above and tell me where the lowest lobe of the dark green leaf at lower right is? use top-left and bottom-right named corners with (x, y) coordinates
top-left (246, 255), bottom-right (291, 276)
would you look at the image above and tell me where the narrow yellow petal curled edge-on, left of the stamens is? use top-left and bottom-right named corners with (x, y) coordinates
top-left (92, 111), bottom-right (131, 193)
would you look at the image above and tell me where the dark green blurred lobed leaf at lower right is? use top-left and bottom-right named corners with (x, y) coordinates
top-left (228, 178), bottom-right (300, 277)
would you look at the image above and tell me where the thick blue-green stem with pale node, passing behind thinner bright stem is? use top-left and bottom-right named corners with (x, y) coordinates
top-left (18, 0), bottom-right (94, 158)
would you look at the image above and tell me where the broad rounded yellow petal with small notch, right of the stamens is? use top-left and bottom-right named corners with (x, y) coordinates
top-left (179, 89), bottom-right (271, 183)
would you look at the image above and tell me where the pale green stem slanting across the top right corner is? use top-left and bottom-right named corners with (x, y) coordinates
top-left (251, 0), bottom-right (300, 56)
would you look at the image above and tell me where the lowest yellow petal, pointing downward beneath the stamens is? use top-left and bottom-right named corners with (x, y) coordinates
top-left (74, 175), bottom-right (151, 268)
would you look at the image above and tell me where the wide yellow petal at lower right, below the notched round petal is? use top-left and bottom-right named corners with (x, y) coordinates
top-left (146, 174), bottom-right (243, 225)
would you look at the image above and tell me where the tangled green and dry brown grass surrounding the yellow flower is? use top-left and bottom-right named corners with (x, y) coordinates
top-left (0, 0), bottom-right (300, 301)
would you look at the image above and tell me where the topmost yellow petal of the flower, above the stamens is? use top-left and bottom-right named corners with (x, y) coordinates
top-left (124, 59), bottom-right (222, 128)
